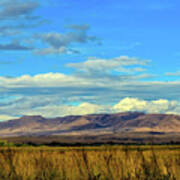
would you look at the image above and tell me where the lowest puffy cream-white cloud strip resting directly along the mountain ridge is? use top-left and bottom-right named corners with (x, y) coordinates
top-left (0, 97), bottom-right (180, 120)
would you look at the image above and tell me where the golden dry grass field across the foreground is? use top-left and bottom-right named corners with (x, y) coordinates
top-left (0, 145), bottom-right (180, 180)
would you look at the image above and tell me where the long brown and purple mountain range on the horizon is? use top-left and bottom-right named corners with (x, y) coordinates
top-left (0, 112), bottom-right (180, 137)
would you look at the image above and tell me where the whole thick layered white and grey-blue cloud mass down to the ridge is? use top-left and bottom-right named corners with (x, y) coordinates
top-left (0, 56), bottom-right (180, 120)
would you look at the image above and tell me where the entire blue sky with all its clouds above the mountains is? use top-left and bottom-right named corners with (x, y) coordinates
top-left (0, 0), bottom-right (180, 121)
